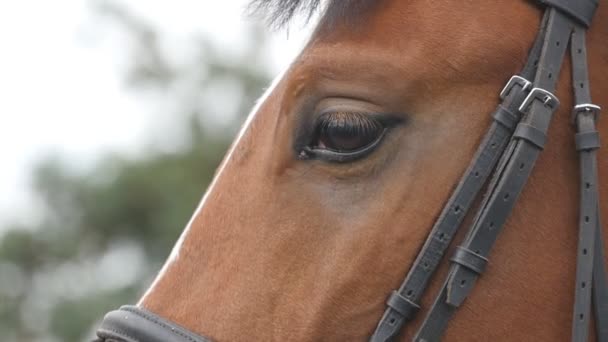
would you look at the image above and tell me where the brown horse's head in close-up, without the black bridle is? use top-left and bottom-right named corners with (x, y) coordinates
top-left (97, 0), bottom-right (608, 341)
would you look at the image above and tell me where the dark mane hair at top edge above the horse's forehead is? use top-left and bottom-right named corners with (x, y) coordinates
top-left (248, 0), bottom-right (379, 29)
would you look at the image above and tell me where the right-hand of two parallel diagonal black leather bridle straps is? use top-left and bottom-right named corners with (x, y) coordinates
top-left (415, 8), bottom-right (572, 341)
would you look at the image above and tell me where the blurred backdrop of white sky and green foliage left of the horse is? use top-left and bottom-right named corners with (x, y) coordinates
top-left (0, 0), bottom-right (309, 342)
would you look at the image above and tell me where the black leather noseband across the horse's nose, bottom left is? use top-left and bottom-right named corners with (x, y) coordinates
top-left (95, 305), bottom-right (211, 342)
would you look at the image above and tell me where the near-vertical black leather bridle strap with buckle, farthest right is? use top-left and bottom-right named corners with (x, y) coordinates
top-left (571, 27), bottom-right (608, 342)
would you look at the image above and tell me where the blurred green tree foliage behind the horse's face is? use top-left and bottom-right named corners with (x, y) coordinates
top-left (0, 3), bottom-right (269, 342)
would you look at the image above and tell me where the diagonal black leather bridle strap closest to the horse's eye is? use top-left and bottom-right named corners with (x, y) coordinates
top-left (370, 12), bottom-right (548, 342)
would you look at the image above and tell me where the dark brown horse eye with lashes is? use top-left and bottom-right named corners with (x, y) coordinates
top-left (311, 112), bottom-right (385, 153)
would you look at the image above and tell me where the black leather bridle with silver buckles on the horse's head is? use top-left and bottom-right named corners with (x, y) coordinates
top-left (92, 0), bottom-right (608, 342)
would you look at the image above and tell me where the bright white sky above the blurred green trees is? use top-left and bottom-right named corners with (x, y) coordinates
top-left (0, 0), bottom-right (307, 231)
